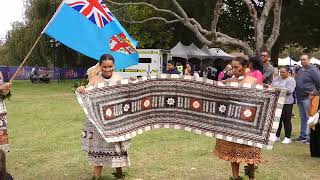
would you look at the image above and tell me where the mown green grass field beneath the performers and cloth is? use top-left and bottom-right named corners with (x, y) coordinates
top-left (6, 81), bottom-right (320, 180)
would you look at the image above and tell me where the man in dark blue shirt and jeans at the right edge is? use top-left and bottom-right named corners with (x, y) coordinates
top-left (295, 54), bottom-right (320, 144)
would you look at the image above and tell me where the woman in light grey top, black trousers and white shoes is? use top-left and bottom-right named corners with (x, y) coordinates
top-left (272, 66), bottom-right (296, 144)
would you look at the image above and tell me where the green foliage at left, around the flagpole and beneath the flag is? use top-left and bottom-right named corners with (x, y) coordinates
top-left (0, 0), bottom-right (95, 67)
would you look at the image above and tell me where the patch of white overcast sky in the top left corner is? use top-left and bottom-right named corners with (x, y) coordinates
top-left (0, 0), bottom-right (24, 39)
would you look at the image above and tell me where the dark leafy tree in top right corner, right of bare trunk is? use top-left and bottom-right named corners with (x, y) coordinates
top-left (271, 0), bottom-right (320, 62)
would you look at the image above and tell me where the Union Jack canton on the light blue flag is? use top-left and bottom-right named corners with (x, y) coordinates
top-left (66, 0), bottom-right (114, 28)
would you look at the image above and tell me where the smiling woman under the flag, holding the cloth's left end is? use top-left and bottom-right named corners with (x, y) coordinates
top-left (77, 54), bottom-right (131, 178)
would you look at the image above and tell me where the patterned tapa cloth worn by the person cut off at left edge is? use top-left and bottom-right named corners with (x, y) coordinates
top-left (0, 99), bottom-right (9, 152)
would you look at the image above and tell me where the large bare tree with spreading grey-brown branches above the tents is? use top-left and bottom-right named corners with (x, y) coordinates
top-left (108, 0), bottom-right (282, 56)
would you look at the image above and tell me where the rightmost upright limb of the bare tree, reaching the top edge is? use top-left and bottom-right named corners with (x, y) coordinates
top-left (266, 0), bottom-right (282, 51)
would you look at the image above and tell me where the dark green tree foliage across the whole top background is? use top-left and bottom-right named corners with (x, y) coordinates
top-left (0, 0), bottom-right (320, 67)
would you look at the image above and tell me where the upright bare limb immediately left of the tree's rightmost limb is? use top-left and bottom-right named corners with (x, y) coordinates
top-left (255, 0), bottom-right (276, 53)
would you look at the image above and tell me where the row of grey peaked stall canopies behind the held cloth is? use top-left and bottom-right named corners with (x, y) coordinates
top-left (171, 42), bottom-right (232, 60)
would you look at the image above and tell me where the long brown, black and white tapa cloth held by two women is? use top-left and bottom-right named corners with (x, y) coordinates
top-left (76, 74), bottom-right (286, 149)
